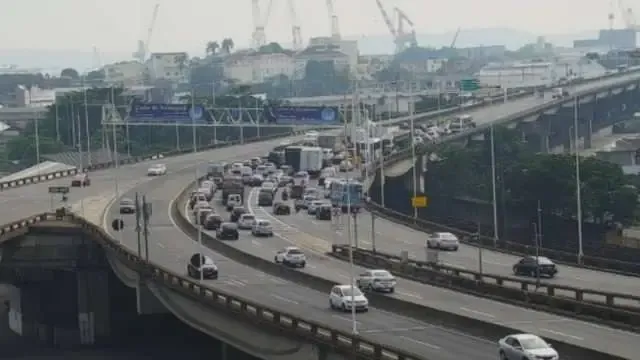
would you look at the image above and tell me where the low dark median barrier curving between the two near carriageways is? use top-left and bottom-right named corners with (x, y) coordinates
top-left (170, 175), bottom-right (622, 360)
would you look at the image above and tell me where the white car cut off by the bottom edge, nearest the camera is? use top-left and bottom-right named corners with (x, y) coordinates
top-left (498, 334), bottom-right (560, 360)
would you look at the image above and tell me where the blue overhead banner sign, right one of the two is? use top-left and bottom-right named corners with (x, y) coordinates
top-left (265, 106), bottom-right (341, 125)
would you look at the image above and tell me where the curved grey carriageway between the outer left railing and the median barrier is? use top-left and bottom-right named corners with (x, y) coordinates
top-left (104, 165), bottom-right (496, 360)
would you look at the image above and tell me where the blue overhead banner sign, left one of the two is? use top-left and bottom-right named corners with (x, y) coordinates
top-left (129, 104), bottom-right (206, 123)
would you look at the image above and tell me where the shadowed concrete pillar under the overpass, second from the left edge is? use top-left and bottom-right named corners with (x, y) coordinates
top-left (76, 270), bottom-right (111, 345)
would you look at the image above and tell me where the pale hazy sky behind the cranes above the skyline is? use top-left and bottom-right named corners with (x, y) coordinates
top-left (0, 0), bottom-right (640, 52)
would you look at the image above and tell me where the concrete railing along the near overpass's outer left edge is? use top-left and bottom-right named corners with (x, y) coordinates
top-left (1, 213), bottom-right (428, 360)
